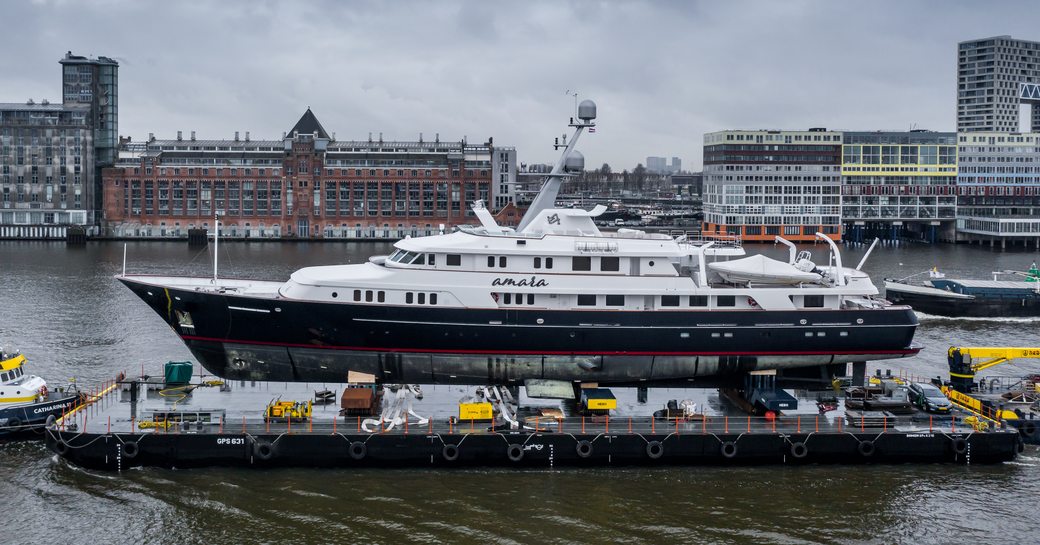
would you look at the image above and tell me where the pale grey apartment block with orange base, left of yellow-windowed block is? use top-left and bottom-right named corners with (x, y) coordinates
top-left (703, 128), bottom-right (841, 241)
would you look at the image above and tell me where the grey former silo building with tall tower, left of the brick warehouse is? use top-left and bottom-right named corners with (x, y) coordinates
top-left (0, 52), bottom-right (119, 238)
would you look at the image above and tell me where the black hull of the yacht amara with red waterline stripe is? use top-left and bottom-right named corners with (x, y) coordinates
top-left (120, 278), bottom-right (919, 384)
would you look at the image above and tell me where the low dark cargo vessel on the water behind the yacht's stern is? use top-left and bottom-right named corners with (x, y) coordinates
top-left (885, 263), bottom-right (1040, 318)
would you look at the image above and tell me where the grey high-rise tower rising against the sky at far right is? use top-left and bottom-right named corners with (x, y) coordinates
top-left (957, 36), bottom-right (1040, 132)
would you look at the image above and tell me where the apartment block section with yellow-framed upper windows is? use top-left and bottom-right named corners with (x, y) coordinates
top-left (841, 131), bottom-right (957, 241)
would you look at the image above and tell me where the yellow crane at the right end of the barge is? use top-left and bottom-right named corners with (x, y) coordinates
top-left (942, 346), bottom-right (1040, 420)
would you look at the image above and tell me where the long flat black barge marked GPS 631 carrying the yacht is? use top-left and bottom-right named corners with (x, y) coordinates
top-left (47, 378), bottom-right (1022, 470)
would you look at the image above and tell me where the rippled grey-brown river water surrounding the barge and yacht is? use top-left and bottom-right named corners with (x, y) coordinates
top-left (0, 241), bottom-right (1040, 544)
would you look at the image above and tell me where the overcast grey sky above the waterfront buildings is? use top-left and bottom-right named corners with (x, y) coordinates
top-left (0, 0), bottom-right (1040, 171)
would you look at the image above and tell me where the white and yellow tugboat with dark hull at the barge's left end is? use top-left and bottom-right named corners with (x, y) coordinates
top-left (0, 347), bottom-right (80, 437)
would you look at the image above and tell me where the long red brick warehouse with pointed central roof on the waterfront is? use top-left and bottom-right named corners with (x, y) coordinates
top-left (103, 109), bottom-right (519, 238)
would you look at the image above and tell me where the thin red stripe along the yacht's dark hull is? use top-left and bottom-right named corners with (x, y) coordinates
top-left (181, 335), bottom-right (920, 356)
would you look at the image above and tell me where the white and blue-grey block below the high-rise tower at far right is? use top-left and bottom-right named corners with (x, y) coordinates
top-left (957, 132), bottom-right (1040, 248)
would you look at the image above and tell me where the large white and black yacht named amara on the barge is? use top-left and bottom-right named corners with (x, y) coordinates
top-left (116, 101), bottom-right (920, 385)
